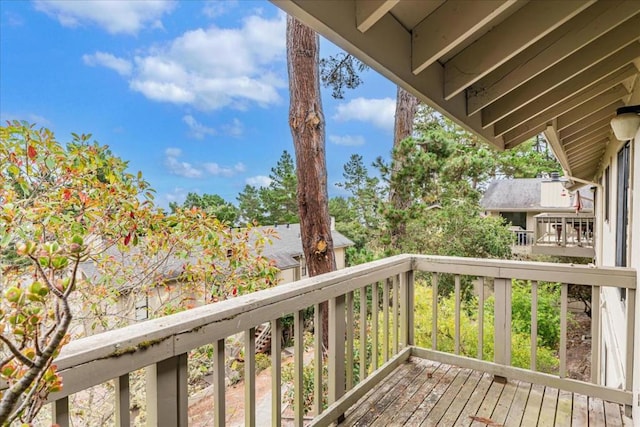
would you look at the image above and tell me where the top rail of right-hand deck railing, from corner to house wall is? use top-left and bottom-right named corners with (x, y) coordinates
top-left (413, 255), bottom-right (637, 289)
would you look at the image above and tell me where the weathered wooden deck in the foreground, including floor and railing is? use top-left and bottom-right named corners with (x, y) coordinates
top-left (45, 255), bottom-right (640, 427)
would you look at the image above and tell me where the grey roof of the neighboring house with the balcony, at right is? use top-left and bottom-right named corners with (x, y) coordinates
top-left (480, 178), bottom-right (593, 212)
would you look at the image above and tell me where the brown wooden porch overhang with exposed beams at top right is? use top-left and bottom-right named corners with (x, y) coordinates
top-left (272, 0), bottom-right (640, 180)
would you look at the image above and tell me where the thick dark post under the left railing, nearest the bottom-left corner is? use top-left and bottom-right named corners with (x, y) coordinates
top-left (156, 353), bottom-right (189, 427)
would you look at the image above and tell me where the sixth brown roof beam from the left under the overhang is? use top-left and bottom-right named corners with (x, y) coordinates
top-left (494, 42), bottom-right (640, 135)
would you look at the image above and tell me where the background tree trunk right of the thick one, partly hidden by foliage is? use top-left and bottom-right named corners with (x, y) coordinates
top-left (389, 86), bottom-right (419, 249)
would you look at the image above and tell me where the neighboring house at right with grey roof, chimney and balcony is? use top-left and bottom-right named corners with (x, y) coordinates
top-left (480, 173), bottom-right (595, 258)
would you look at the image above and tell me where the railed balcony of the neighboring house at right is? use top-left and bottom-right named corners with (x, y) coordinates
top-left (531, 213), bottom-right (595, 258)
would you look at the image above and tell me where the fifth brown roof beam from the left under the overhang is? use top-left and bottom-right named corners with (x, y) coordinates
top-left (482, 15), bottom-right (640, 126)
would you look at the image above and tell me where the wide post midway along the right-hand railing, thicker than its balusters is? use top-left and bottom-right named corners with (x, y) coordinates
top-left (493, 279), bottom-right (511, 380)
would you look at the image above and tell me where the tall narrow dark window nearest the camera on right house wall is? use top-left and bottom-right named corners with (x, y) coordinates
top-left (616, 142), bottom-right (631, 301)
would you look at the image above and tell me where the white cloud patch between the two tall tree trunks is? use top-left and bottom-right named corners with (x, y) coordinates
top-left (333, 98), bottom-right (396, 132)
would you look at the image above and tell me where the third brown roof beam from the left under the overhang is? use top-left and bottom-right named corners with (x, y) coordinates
top-left (444, 0), bottom-right (595, 100)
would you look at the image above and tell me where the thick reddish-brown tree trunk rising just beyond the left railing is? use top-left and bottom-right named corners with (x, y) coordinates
top-left (287, 16), bottom-right (336, 348)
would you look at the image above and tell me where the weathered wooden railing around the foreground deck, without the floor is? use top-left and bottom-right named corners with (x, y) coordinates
top-left (46, 255), bottom-right (640, 427)
